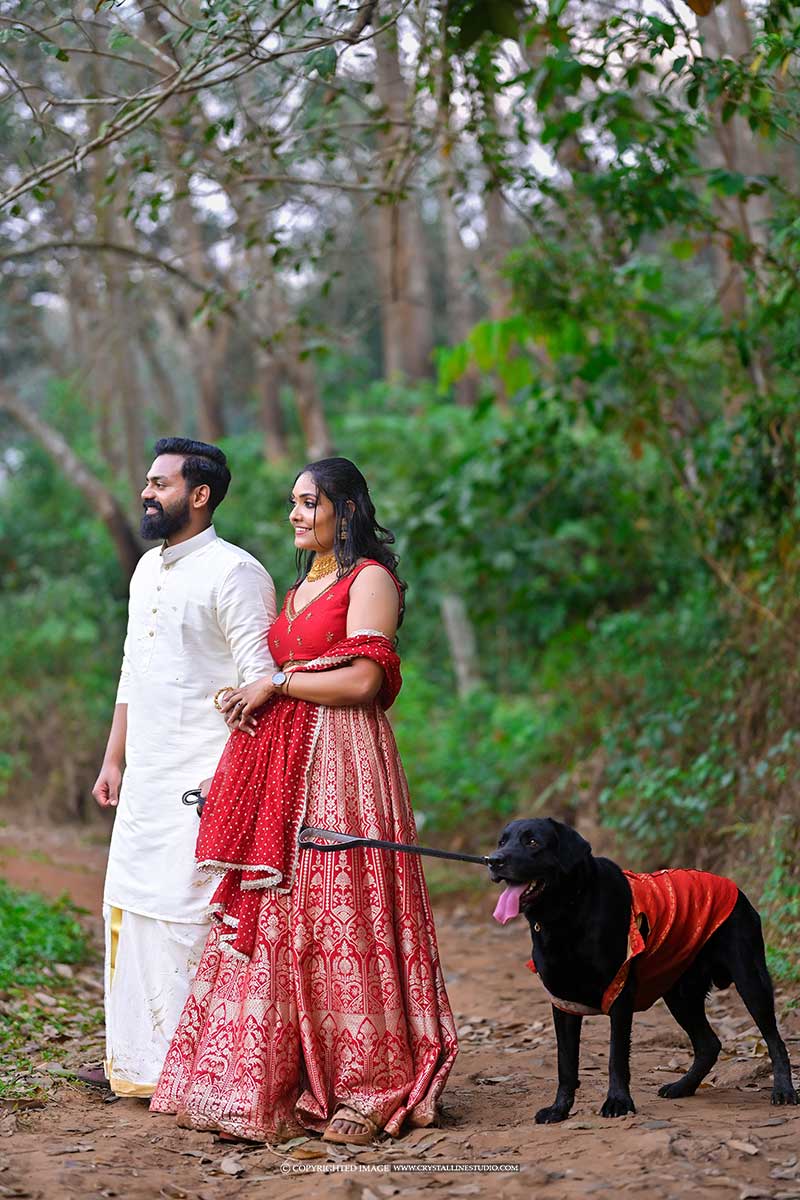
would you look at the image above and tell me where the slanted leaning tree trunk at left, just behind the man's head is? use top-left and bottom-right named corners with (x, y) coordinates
top-left (0, 389), bottom-right (142, 580)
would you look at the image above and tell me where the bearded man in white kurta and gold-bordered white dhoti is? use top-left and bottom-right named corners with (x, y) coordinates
top-left (86, 438), bottom-right (276, 1097)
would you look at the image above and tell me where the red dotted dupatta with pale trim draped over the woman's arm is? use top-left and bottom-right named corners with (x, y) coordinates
top-left (194, 630), bottom-right (402, 958)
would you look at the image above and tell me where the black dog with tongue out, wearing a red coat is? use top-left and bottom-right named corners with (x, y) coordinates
top-left (488, 818), bottom-right (798, 1124)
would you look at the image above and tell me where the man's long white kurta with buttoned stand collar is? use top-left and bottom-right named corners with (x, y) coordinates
top-left (103, 527), bottom-right (276, 923)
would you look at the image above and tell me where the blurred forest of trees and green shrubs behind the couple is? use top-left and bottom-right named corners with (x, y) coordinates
top-left (0, 0), bottom-right (800, 978)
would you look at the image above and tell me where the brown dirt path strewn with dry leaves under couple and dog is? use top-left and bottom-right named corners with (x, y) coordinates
top-left (0, 830), bottom-right (800, 1200)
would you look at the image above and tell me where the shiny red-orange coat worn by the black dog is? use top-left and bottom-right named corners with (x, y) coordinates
top-left (528, 869), bottom-right (739, 1013)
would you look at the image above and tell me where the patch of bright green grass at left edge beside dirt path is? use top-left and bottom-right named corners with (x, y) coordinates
top-left (0, 880), bottom-right (89, 991)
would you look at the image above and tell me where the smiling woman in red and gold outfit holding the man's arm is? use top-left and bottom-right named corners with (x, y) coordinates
top-left (151, 458), bottom-right (457, 1144)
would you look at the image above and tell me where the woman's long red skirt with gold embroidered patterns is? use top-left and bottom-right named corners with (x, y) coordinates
top-left (151, 706), bottom-right (457, 1141)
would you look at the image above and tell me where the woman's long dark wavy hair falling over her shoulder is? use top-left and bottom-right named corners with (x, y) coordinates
top-left (295, 458), bottom-right (407, 625)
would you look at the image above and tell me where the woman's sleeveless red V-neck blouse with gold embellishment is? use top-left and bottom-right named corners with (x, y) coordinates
top-left (267, 558), bottom-right (403, 667)
